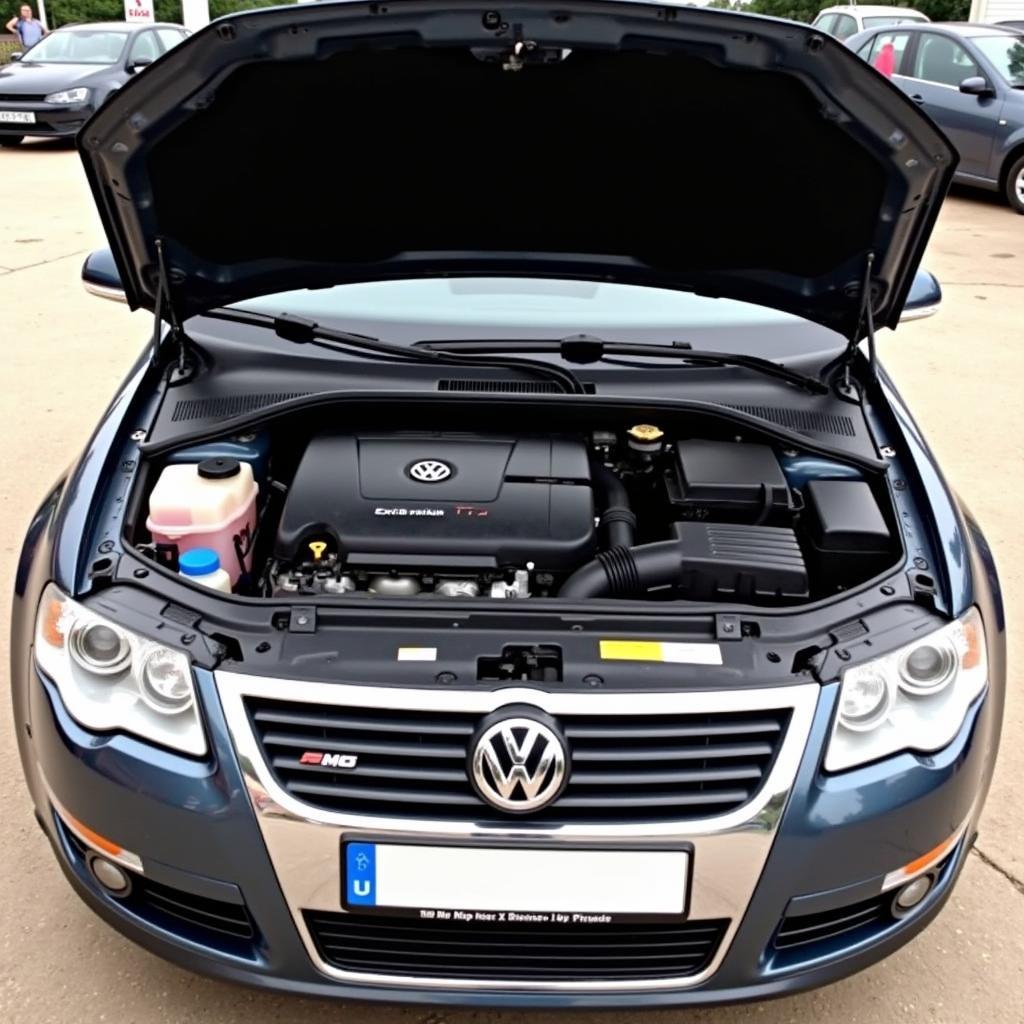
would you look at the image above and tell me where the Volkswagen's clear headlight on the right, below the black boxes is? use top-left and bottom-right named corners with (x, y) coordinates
top-left (825, 608), bottom-right (988, 771)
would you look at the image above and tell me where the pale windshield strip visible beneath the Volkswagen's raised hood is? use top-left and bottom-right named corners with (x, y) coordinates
top-left (238, 278), bottom-right (845, 359)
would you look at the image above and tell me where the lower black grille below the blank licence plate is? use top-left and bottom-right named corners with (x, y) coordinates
top-left (303, 910), bottom-right (728, 981)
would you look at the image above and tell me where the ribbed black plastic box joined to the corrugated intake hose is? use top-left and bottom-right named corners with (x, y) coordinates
top-left (673, 522), bottom-right (810, 601)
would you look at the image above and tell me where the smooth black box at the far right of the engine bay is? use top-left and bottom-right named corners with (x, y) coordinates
top-left (804, 480), bottom-right (892, 555)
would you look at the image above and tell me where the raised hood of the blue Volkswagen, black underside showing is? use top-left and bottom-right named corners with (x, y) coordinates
top-left (79, 0), bottom-right (956, 338)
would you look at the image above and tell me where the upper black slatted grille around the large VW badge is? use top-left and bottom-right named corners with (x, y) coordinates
top-left (246, 697), bottom-right (790, 823)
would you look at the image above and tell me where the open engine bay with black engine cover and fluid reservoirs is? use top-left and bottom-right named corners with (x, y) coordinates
top-left (128, 422), bottom-right (902, 605)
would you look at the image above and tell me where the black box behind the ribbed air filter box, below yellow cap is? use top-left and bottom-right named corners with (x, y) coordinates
top-left (669, 440), bottom-right (791, 522)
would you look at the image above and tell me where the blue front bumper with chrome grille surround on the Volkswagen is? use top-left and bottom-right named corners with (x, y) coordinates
top-left (22, 651), bottom-right (998, 1007)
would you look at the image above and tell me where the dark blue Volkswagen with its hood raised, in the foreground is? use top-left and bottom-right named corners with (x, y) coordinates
top-left (11, 0), bottom-right (1006, 1010)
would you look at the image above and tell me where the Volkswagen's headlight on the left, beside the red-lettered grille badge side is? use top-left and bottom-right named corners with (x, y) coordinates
top-left (36, 584), bottom-right (206, 755)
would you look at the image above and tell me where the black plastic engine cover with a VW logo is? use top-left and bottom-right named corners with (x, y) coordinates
top-left (274, 434), bottom-right (595, 572)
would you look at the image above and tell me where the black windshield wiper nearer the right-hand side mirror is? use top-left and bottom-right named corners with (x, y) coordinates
top-left (416, 335), bottom-right (828, 394)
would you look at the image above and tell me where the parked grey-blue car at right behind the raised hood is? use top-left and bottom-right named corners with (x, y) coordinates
top-left (847, 24), bottom-right (1024, 213)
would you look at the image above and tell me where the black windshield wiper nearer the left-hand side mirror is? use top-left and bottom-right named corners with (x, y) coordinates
top-left (203, 307), bottom-right (587, 394)
